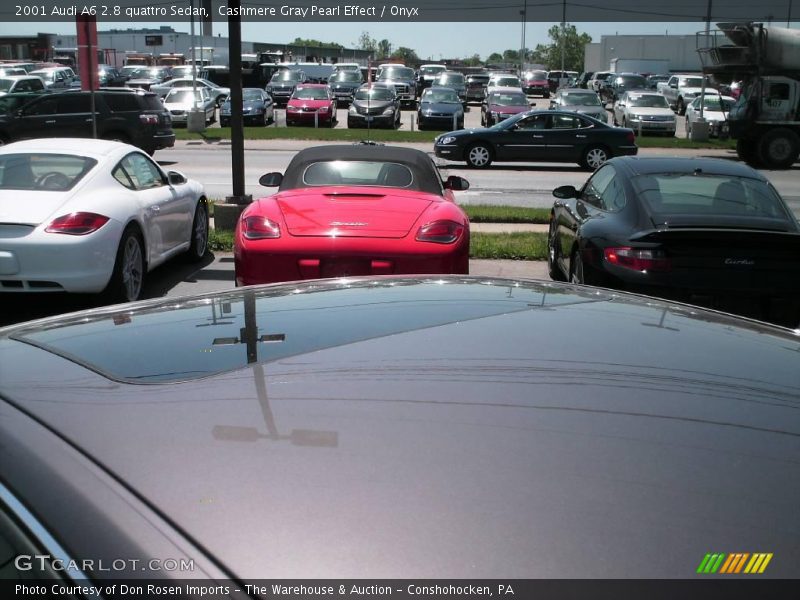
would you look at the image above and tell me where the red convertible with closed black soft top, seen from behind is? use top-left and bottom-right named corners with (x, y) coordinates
top-left (234, 144), bottom-right (469, 285)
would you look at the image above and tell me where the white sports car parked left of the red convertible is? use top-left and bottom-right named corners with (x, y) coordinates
top-left (0, 138), bottom-right (208, 302)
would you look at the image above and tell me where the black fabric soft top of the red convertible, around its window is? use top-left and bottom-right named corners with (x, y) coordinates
top-left (278, 144), bottom-right (443, 196)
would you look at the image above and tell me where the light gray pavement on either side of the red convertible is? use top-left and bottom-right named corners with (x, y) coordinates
top-left (158, 252), bottom-right (550, 297)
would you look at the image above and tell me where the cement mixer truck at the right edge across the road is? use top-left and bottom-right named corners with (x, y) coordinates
top-left (698, 23), bottom-right (800, 169)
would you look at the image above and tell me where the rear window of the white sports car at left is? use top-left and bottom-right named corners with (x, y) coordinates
top-left (0, 153), bottom-right (97, 192)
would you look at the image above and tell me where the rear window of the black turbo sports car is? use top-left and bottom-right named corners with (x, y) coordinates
top-left (632, 173), bottom-right (792, 221)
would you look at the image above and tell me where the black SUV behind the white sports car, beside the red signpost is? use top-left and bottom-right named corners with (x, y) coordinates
top-left (0, 88), bottom-right (175, 154)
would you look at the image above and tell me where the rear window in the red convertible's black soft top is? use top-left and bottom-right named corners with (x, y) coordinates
top-left (303, 160), bottom-right (414, 188)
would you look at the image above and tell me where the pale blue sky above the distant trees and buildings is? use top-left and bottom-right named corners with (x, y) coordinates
top-left (6, 22), bottom-right (712, 60)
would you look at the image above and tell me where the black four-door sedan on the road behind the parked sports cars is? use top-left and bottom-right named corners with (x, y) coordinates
top-left (433, 110), bottom-right (638, 170)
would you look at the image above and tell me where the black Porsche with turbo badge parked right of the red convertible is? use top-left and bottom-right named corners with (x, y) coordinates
top-left (548, 158), bottom-right (800, 327)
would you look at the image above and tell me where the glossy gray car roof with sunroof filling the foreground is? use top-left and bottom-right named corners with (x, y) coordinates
top-left (0, 276), bottom-right (800, 580)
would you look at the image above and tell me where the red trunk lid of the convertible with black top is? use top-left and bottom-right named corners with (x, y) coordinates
top-left (263, 186), bottom-right (434, 238)
